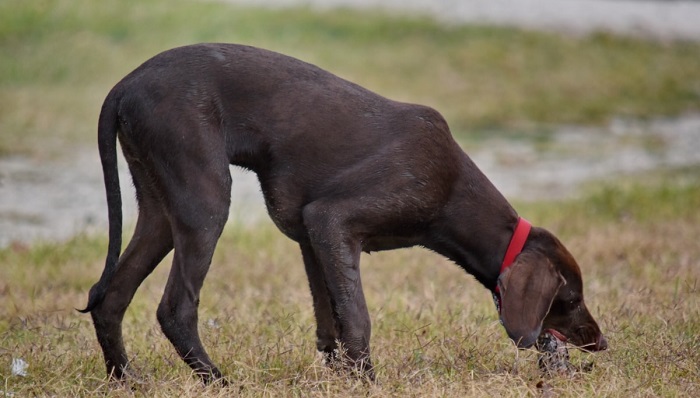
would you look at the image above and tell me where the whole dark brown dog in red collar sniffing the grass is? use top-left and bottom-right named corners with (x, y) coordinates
top-left (81, 44), bottom-right (607, 383)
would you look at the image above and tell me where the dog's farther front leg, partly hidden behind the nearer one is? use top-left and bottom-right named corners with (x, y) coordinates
top-left (300, 243), bottom-right (340, 364)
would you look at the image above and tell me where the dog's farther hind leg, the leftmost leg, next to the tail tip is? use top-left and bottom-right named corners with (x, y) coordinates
top-left (91, 194), bottom-right (173, 379)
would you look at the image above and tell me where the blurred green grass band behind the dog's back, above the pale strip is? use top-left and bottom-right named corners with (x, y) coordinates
top-left (0, 0), bottom-right (700, 156)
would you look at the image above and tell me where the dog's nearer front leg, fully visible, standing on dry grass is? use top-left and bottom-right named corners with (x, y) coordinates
top-left (302, 202), bottom-right (374, 380)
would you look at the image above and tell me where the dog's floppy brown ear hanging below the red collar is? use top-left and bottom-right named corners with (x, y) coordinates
top-left (498, 252), bottom-right (565, 348)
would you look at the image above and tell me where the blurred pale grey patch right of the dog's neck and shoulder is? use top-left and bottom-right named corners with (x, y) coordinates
top-left (467, 114), bottom-right (700, 200)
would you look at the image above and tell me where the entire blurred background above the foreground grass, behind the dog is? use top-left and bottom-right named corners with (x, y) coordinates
top-left (0, 0), bottom-right (700, 247)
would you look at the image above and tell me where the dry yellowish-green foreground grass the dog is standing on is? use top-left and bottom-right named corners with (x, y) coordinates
top-left (0, 173), bottom-right (700, 397)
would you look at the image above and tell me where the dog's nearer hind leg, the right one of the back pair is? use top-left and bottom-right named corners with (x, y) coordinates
top-left (157, 159), bottom-right (231, 383)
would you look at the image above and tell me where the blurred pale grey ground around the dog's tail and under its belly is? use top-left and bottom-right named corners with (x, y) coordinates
top-left (0, 149), bottom-right (265, 247)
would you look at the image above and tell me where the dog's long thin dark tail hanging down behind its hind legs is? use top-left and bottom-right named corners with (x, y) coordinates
top-left (78, 91), bottom-right (122, 313)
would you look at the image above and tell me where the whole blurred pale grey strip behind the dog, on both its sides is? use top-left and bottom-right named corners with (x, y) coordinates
top-left (0, 114), bottom-right (700, 247)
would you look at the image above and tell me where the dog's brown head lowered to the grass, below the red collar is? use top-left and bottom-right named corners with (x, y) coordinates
top-left (498, 228), bottom-right (608, 351)
